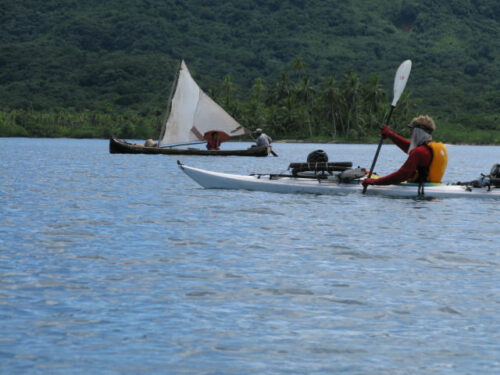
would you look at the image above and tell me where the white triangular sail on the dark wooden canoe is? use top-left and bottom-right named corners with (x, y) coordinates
top-left (159, 61), bottom-right (249, 146)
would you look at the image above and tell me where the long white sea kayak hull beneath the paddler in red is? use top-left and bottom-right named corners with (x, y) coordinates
top-left (178, 162), bottom-right (500, 199)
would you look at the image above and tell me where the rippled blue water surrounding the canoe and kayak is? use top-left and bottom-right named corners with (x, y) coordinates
top-left (0, 139), bottom-right (500, 374)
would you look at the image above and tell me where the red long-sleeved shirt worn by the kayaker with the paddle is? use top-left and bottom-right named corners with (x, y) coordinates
top-left (373, 130), bottom-right (432, 185)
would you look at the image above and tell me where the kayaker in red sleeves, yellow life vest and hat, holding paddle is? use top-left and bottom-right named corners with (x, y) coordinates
top-left (363, 116), bottom-right (448, 186)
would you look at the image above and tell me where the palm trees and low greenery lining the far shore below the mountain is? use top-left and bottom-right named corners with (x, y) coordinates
top-left (0, 56), bottom-right (415, 141)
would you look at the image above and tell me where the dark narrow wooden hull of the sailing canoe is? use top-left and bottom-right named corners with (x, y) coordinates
top-left (109, 138), bottom-right (271, 157)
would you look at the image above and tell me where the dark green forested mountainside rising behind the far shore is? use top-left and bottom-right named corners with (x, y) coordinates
top-left (0, 0), bottom-right (500, 142)
